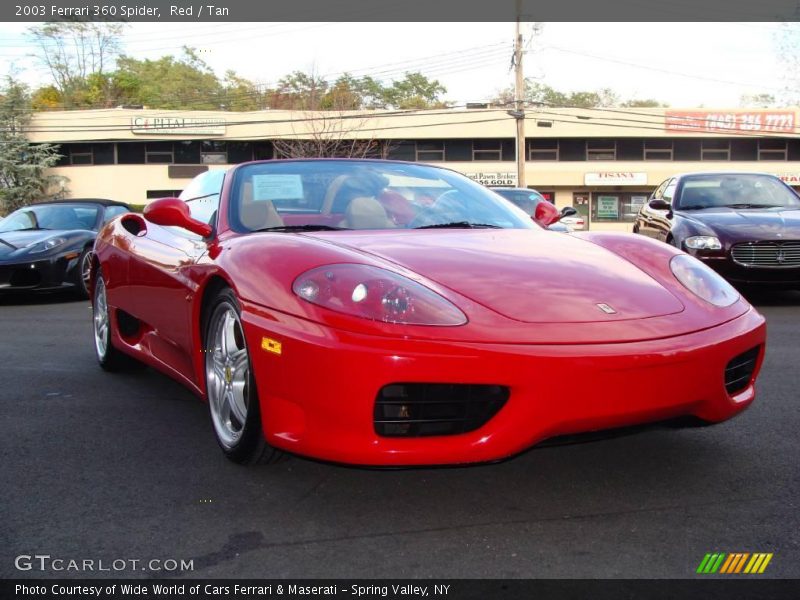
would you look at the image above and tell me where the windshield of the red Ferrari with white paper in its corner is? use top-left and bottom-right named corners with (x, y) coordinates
top-left (230, 160), bottom-right (536, 231)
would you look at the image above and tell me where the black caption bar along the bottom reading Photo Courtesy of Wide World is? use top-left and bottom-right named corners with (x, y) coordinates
top-left (0, 576), bottom-right (800, 600)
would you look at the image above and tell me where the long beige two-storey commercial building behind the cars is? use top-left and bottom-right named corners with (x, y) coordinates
top-left (31, 106), bottom-right (800, 230)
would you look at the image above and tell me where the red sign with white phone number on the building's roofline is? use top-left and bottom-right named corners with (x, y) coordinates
top-left (665, 110), bottom-right (795, 133)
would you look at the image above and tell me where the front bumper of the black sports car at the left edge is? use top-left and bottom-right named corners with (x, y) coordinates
top-left (0, 252), bottom-right (80, 293)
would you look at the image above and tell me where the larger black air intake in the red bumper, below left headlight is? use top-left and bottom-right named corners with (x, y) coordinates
top-left (375, 383), bottom-right (509, 437)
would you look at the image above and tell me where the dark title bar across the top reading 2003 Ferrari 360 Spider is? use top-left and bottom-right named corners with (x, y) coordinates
top-left (0, 0), bottom-right (800, 22)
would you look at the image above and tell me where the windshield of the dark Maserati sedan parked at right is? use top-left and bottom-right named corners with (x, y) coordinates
top-left (676, 173), bottom-right (800, 210)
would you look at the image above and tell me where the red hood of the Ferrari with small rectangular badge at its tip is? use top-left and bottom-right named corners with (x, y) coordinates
top-left (313, 229), bottom-right (684, 323)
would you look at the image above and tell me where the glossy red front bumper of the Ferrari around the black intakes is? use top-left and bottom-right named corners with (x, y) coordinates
top-left (243, 303), bottom-right (766, 466)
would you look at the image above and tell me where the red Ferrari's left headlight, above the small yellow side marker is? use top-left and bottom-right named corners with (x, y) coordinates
top-left (292, 264), bottom-right (467, 327)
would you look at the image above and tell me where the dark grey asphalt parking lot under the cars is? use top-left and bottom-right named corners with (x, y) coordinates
top-left (0, 292), bottom-right (800, 578)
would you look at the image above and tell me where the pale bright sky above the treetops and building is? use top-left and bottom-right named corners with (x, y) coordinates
top-left (0, 23), bottom-right (784, 108)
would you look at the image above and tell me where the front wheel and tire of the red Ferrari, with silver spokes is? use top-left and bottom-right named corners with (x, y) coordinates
top-left (203, 288), bottom-right (285, 465)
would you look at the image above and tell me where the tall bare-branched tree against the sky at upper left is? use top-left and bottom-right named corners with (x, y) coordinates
top-left (28, 21), bottom-right (124, 106)
